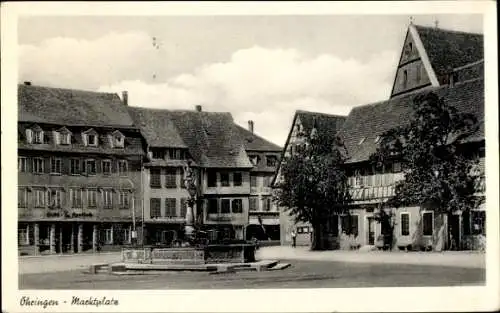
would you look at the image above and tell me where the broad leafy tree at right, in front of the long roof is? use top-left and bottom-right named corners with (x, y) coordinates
top-left (371, 92), bottom-right (478, 249)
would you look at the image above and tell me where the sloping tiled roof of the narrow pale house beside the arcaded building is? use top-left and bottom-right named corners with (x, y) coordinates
top-left (128, 107), bottom-right (187, 148)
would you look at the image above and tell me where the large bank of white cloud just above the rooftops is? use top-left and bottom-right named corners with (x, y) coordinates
top-left (20, 33), bottom-right (397, 145)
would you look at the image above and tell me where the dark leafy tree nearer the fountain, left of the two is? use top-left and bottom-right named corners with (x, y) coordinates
top-left (274, 128), bottom-right (351, 250)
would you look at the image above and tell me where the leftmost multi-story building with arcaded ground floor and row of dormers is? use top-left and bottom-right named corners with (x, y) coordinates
top-left (18, 82), bottom-right (143, 254)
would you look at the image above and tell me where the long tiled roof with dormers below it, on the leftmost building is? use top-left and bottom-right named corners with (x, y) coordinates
top-left (17, 85), bottom-right (133, 127)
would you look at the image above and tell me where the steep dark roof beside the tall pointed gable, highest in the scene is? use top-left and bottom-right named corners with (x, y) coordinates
top-left (415, 25), bottom-right (484, 77)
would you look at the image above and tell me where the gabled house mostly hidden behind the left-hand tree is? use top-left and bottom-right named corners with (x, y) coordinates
top-left (272, 110), bottom-right (346, 245)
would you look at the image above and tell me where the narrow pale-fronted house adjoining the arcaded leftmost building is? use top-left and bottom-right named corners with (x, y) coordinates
top-left (129, 107), bottom-right (191, 244)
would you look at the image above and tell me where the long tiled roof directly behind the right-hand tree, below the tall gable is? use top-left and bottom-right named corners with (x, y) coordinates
top-left (340, 79), bottom-right (484, 163)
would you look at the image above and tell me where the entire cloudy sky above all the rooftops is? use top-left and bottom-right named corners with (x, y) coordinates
top-left (18, 15), bottom-right (482, 146)
